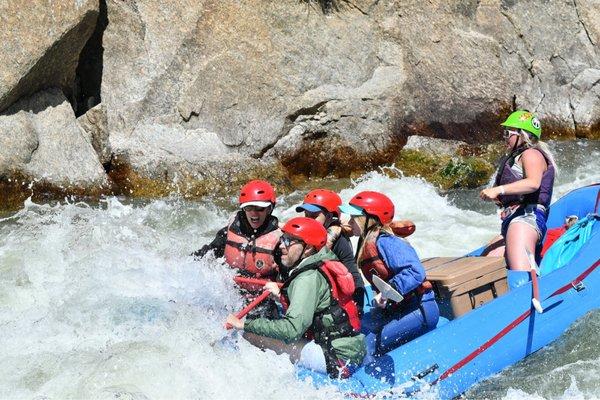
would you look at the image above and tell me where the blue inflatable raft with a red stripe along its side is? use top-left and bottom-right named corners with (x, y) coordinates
top-left (298, 184), bottom-right (600, 399)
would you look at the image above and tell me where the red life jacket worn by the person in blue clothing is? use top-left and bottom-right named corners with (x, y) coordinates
top-left (357, 229), bottom-right (433, 300)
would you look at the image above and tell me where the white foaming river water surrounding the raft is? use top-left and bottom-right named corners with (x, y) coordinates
top-left (0, 141), bottom-right (600, 400)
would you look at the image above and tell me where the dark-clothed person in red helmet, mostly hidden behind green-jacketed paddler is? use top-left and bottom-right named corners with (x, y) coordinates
top-left (296, 189), bottom-right (365, 314)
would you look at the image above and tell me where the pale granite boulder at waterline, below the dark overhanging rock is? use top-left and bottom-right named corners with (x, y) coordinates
top-left (0, 88), bottom-right (108, 188)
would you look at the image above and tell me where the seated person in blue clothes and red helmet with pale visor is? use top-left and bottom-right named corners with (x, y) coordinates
top-left (339, 191), bottom-right (439, 364)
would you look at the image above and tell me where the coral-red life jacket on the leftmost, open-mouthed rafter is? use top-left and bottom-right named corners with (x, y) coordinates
top-left (225, 224), bottom-right (281, 278)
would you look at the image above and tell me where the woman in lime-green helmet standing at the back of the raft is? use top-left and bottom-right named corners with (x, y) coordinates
top-left (479, 110), bottom-right (557, 287)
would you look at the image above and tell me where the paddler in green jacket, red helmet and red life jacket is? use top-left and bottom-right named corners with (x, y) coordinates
top-left (227, 217), bottom-right (366, 378)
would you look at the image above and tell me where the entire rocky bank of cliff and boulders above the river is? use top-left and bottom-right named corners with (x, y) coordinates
top-left (0, 0), bottom-right (600, 209)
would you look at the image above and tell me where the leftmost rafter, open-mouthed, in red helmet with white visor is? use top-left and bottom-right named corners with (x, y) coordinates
top-left (193, 180), bottom-right (281, 280)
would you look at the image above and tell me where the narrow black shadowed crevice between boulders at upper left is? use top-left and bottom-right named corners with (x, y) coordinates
top-left (73, 0), bottom-right (108, 117)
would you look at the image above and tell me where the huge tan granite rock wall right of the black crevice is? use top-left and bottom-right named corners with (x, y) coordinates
top-left (102, 0), bottom-right (600, 180)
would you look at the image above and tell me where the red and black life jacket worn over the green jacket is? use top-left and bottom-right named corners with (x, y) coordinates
top-left (281, 260), bottom-right (360, 336)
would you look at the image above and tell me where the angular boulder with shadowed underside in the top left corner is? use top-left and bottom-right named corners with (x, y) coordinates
top-left (0, 0), bottom-right (98, 112)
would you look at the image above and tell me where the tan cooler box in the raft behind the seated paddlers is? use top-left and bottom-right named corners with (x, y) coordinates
top-left (422, 257), bottom-right (508, 319)
